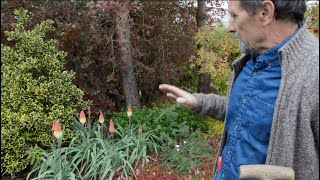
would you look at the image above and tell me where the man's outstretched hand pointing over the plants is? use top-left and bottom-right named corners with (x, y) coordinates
top-left (159, 84), bottom-right (198, 109)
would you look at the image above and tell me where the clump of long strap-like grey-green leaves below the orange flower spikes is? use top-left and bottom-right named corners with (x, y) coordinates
top-left (27, 121), bottom-right (162, 180)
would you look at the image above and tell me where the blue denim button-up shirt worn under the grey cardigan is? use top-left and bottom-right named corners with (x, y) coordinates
top-left (214, 25), bottom-right (297, 180)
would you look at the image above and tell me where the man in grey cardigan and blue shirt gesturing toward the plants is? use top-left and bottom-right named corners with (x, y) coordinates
top-left (159, 0), bottom-right (319, 180)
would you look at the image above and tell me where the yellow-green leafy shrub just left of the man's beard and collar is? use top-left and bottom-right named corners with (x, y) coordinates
top-left (189, 25), bottom-right (240, 95)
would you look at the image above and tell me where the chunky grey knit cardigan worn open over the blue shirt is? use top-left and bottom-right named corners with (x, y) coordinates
top-left (192, 25), bottom-right (319, 180)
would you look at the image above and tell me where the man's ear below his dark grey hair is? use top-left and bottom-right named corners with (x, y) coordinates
top-left (259, 0), bottom-right (275, 25)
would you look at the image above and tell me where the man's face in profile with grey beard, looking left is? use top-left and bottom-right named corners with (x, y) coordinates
top-left (228, 0), bottom-right (265, 56)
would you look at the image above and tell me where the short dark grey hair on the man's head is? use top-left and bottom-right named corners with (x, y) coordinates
top-left (240, 0), bottom-right (307, 24)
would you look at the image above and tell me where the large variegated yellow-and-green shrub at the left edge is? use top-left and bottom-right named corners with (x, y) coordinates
top-left (1, 9), bottom-right (88, 175)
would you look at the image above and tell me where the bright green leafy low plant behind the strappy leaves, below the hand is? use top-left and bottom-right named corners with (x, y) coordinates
top-left (112, 104), bottom-right (208, 140)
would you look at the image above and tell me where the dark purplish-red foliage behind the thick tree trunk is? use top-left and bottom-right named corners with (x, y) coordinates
top-left (1, 0), bottom-right (229, 114)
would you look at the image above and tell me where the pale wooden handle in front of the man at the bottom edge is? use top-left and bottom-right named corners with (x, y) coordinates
top-left (239, 164), bottom-right (294, 180)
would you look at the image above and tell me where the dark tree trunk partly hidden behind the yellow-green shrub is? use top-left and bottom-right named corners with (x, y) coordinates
top-left (196, 0), bottom-right (210, 93)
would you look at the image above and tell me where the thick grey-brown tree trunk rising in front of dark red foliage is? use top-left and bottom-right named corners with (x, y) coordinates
top-left (116, 0), bottom-right (140, 108)
